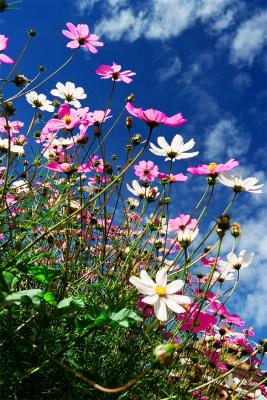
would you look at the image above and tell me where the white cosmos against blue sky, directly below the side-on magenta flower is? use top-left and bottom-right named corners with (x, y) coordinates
top-left (149, 135), bottom-right (199, 161)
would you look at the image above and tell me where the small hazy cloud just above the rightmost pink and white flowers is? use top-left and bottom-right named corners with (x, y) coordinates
top-left (205, 117), bottom-right (250, 161)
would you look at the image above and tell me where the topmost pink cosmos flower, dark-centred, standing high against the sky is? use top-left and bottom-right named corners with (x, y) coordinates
top-left (62, 22), bottom-right (104, 54)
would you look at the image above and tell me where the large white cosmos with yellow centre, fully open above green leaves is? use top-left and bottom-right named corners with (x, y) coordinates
top-left (129, 269), bottom-right (191, 321)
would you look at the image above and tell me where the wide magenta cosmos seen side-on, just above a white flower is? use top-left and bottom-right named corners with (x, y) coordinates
top-left (125, 102), bottom-right (187, 128)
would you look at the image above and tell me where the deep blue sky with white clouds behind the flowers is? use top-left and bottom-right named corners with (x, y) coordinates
top-left (0, 0), bottom-right (267, 344)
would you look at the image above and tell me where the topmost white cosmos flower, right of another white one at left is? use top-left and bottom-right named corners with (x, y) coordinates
top-left (50, 82), bottom-right (87, 108)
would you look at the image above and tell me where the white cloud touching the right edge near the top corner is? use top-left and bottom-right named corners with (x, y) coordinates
top-left (230, 11), bottom-right (267, 65)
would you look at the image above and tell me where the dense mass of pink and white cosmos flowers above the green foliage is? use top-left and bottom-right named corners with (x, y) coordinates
top-left (0, 23), bottom-right (266, 400)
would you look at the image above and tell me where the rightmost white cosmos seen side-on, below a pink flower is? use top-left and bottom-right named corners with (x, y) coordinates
top-left (217, 174), bottom-right (263, 193)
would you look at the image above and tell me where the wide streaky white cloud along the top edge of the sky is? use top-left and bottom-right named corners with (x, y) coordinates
top-left (81, 0), bottom-right (239, 41)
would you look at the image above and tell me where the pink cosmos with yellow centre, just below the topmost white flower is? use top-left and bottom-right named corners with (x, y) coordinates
top-left (44, 104), bottom-right (81, 132)
